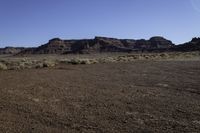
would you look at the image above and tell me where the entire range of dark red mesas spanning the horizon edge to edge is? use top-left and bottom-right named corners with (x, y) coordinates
top-left (0, 36), bottom-right (200, 55)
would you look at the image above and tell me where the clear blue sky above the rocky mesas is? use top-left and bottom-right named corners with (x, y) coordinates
top-left (0, 0), bottom-right (200, 47)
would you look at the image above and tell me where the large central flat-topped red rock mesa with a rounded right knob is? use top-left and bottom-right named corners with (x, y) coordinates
top-left (18, 37), bottom-right (174, 54)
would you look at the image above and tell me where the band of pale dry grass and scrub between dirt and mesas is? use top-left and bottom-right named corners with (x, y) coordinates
top-left (0, 52), bottom-right (200, 70)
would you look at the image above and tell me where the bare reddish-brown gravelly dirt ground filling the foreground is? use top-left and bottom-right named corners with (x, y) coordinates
top-left (0, 61), bottom-right (200, 133)
